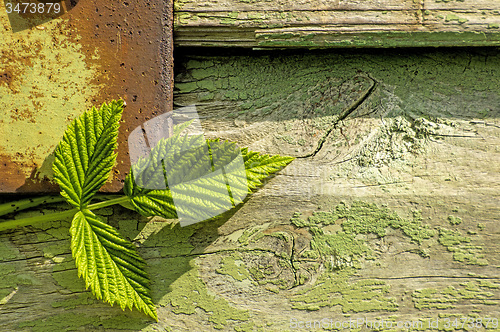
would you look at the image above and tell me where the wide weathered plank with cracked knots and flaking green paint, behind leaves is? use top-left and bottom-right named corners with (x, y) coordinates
top-left (0, 50), bottom-right (500, 331)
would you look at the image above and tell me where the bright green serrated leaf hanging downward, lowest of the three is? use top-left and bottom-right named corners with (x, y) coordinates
top-left (70, 209), bottom-right (158, 320)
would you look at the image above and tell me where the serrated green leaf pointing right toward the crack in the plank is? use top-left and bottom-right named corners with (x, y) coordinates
top-left (124, 120), bottom-right (294, 220)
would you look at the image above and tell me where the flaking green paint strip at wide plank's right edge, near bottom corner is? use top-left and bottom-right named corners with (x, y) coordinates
top-left (412, 280), bottom-right (500, 310)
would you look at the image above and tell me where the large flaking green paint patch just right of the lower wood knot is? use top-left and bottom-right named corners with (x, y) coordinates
top-left (291, 201), bottom-right (434, 312)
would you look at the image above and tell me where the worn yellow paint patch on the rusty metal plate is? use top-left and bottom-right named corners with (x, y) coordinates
top-left (0, 11), bottom-right (99, 178)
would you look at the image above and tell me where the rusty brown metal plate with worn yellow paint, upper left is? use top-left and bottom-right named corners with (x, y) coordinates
top-left (0, 0), bottom-right (173, 193)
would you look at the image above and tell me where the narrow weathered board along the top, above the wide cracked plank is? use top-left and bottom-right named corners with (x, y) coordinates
top-left (174, 0), bottom-right (500, 48)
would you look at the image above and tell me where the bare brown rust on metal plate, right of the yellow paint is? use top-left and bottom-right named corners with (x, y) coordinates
top-left (63, 0), bottom-right (173, 192)
